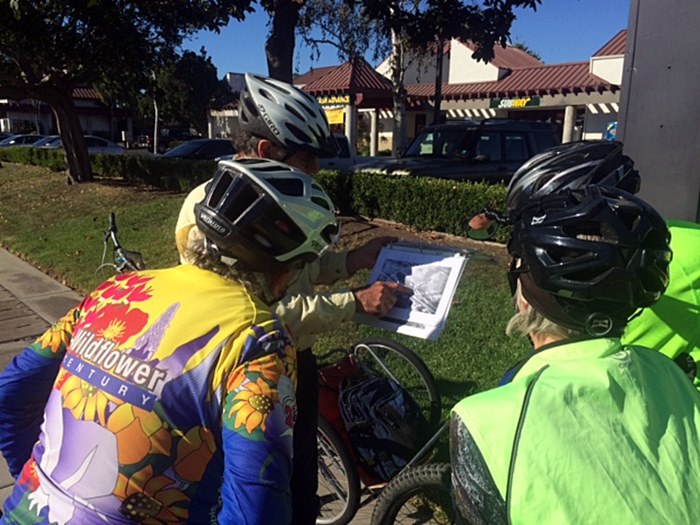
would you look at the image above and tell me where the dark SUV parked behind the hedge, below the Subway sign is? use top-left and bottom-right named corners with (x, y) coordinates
top-left (353, 119), bottom-right (558, 183)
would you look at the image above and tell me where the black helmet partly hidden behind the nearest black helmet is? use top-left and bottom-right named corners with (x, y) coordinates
top-left (506, 140), bottom-right (640, 221)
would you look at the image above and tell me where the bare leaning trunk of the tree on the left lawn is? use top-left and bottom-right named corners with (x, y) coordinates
top-left (47, 90), bottom-right (92, 184)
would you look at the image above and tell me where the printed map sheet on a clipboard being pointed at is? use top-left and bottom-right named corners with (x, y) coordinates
top-left (353, 242), bottom-right (469, 341)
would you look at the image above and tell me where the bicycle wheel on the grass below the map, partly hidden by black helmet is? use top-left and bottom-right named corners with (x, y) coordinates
top-left (352, 338), bottom-right (442, 434)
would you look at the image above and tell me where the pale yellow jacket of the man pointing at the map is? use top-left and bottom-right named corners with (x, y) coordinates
top-left (175, 181), bottom-right (355, 350)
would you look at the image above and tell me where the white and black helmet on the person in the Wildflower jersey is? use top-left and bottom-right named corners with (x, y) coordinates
top-left (195, 159), bottom-right (339, 272)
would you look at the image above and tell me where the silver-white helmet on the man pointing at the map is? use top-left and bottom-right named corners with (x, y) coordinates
top-left (238, 73), bottom-right (338, 157)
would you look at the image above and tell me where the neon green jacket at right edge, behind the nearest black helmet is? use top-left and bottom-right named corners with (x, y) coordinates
top-left (622, 221), bottom-right (700, 389)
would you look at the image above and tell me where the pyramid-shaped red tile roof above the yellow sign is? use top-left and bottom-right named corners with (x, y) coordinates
top-left (303, 58), bottom-right (391, 96)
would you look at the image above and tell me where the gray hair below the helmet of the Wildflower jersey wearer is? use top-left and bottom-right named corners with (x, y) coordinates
top-left (184, 226), bottom-right (274, 304)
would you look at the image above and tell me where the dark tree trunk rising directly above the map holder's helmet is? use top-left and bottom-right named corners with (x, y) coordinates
top-left (265, 0), bottom-right (304, 84)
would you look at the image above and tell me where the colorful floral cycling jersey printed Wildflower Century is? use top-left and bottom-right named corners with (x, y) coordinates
top-left (0, 266), bottom-right (296, 525)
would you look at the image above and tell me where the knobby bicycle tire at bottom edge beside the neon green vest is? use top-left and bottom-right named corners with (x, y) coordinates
top-left (372, 463), bottom-right (455, 525)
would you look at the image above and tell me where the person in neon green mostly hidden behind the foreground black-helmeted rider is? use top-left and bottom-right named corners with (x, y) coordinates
top-left (476, 140), bottom-right (700, 389)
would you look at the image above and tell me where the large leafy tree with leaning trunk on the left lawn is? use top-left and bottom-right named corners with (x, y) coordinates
top-left (0, 0), bottom-right (251, 182)
